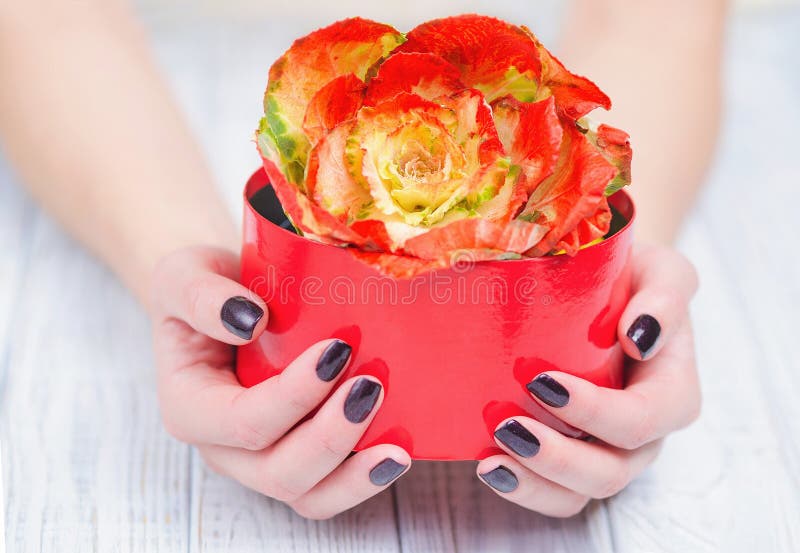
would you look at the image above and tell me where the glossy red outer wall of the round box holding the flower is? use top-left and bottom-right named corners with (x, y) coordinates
top-left (237, 170), bottom-right (634, 460)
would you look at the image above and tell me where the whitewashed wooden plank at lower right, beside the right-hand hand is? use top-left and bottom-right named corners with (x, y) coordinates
top-left (610, 221), bottom-right (800, 552)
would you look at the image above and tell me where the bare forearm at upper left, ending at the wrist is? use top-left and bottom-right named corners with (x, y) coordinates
top-left (0, 0), bottom-right (236, 304)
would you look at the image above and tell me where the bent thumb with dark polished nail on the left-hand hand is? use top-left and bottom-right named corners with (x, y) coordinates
top-left (153, 248), bottom-right (268, 346)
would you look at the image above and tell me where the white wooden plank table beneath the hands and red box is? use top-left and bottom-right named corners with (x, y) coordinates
top-left (0, 8), bottom-right (800, 553)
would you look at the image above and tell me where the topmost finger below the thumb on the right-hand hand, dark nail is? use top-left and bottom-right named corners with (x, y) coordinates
top-left (527, 319), bottom-right (701, 449)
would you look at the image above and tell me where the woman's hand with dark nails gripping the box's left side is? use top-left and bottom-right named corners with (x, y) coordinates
top-left (153, 247), bottom-right (411, 519)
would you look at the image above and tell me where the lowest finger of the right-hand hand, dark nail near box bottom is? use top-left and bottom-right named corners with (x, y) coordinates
top-left (477, 455), bottom-right (589, 518)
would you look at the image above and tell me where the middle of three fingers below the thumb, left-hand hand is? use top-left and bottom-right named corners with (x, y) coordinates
top-left (192, 377), bottom-right (383, 503)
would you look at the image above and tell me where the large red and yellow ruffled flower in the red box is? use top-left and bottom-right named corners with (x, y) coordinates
top-left (256, 15), bottom-right (631, 277)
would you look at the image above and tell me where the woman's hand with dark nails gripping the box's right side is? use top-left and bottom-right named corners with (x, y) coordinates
top-left (477, 246), bottom-right (700, 517)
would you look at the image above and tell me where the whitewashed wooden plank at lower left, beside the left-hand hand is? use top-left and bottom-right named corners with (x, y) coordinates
top-left (0, 203), bottom-right (189, 553)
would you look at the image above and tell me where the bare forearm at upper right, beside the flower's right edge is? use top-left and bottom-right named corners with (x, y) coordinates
top-left (559, 0), bottom-right (726, 243)
